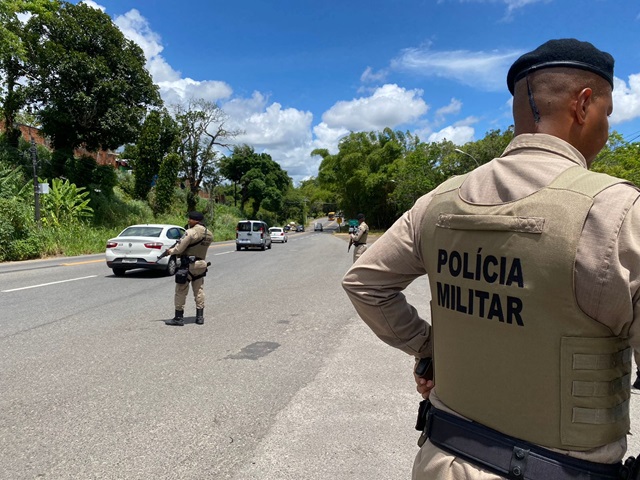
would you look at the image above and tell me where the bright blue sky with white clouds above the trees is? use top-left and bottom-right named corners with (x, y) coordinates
top-left (85, 0), bottom-right (640, 181)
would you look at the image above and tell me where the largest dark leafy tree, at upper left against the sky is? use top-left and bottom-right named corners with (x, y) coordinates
top-left (25, 2), bottom-right (161, 163)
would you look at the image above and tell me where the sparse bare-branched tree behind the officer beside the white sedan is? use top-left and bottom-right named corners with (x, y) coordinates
top-left (173, 99), bottom-right (241, 211)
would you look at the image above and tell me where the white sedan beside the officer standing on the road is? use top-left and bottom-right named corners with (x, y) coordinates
top-left (105, 224), bottom-right (185, 277)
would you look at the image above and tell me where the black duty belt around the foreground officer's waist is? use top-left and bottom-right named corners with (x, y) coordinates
top-left (418, 400), bottom-right (640, 480)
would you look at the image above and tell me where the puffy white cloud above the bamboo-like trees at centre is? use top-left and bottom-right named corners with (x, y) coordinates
top-left (322, 84), bottom-right (429, 131)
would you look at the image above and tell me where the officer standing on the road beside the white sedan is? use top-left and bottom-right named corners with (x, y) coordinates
top-left (167, 212), bottom-right (213, 326)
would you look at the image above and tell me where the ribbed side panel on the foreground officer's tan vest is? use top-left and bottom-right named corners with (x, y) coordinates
top-left (561, 337), bottom-right (632, 447)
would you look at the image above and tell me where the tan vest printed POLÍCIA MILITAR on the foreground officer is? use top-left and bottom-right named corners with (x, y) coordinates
top-left (421, 167), bottom-right (632, 450)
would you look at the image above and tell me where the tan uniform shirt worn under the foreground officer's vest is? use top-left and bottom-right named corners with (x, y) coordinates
top-left (343, 134), bottom-right (640, 463)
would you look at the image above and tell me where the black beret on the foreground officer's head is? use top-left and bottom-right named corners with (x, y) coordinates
top-left (507, 38), bottom-right (613, 95)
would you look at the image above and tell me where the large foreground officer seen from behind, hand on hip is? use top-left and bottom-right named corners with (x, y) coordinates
top-left (343, 39), bottom-right (640, 480)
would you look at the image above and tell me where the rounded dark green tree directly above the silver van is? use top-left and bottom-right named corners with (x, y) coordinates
top-left (220, 145), bottom-right (293, 216)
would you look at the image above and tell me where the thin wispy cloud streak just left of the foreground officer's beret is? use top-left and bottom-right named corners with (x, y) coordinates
top-left (391, 48), bottom-right (523, 91)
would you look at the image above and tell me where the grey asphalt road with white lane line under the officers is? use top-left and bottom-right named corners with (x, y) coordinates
top-left (0, 229), bottom-right (640, 480)
